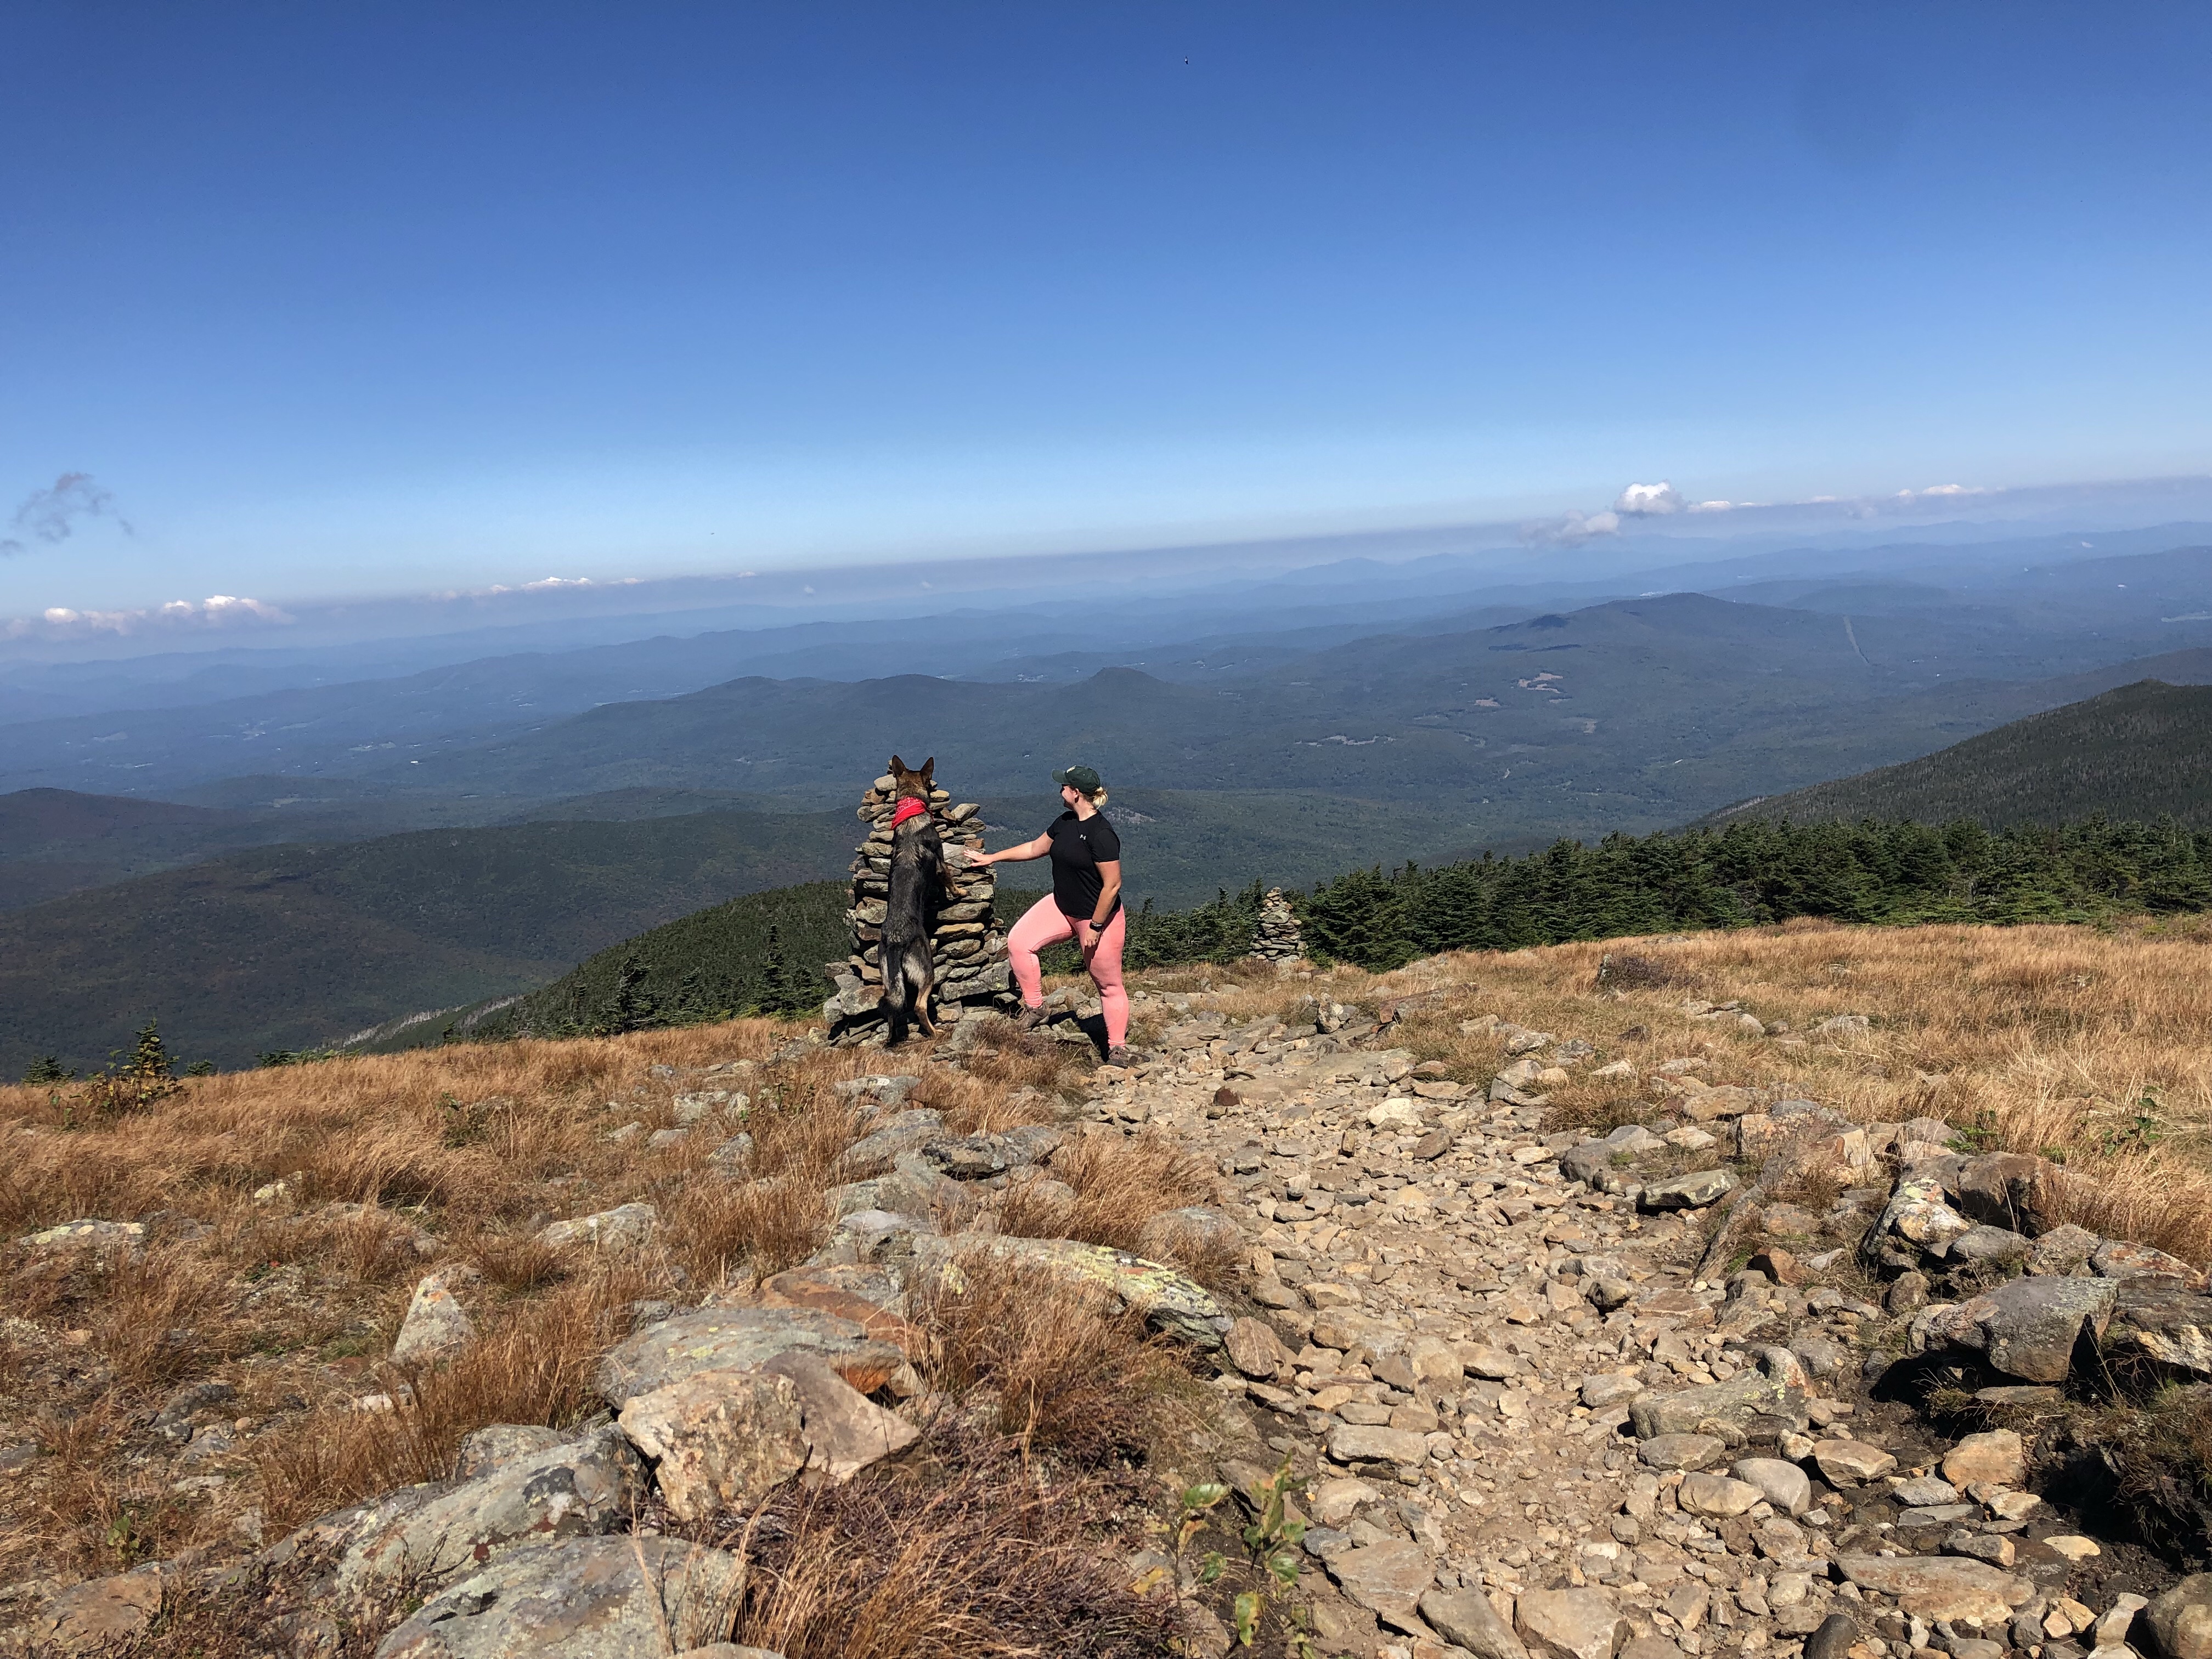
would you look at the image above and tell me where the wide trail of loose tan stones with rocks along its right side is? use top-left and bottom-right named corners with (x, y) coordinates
top-left (1095, 982), bottom-right (2212, 1659)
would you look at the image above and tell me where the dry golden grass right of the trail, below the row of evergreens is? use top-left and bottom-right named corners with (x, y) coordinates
top-left (1186, 918), bottom-right (2212, 1263)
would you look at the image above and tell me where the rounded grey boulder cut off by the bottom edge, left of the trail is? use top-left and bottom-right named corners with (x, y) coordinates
top-left (376, 1537), bottom-right (746, 1659)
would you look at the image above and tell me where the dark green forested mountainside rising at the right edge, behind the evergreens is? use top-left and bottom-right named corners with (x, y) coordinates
top-left (1706, 679), bottom-right (2212, 830)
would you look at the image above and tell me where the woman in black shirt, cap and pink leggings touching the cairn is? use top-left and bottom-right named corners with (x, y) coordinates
top-left (969, 765), bottom-right (1130, 1066)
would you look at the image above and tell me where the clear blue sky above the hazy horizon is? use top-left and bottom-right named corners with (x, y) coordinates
top-left (0, 2), bottom-right (2212, 615)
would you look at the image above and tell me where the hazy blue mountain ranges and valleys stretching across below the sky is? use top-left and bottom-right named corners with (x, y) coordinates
top-left (0, 527), bottom-right (2212, 1073)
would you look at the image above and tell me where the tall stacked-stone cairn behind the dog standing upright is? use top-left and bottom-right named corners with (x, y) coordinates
top-left (823, 772), bottom-right (1013, 1046)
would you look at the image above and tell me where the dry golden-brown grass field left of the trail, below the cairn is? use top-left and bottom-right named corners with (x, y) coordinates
top-left (0, 1020), bottom-right (1124, 1586)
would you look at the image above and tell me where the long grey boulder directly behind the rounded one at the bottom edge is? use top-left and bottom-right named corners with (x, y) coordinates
top-left (327, 1427), bottom-right (646, 1593)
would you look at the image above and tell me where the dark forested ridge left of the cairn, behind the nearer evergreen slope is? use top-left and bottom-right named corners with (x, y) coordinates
top-left (0, 814), bottom-right (851, 1075)
